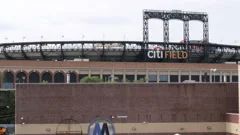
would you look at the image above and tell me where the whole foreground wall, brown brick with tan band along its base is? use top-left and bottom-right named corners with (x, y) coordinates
top-left (16, 83), bottom-right (239, 135)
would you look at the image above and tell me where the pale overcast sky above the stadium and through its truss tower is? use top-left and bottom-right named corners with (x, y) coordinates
top-left (0, 0), bottom-right (240, 44)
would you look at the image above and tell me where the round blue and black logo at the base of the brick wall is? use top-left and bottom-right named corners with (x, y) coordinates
top-left (88, 117), bottom-right (115, 135)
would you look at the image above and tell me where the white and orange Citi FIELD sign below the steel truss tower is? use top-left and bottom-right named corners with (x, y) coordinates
top-left (147, 47), bottom-right (188, 59)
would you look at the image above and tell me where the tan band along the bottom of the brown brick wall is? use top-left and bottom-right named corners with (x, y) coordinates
top-left (16, 122), bottom-right (227, 134)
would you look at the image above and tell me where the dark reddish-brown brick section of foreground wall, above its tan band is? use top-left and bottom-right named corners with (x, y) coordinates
top-left (16, 83), bottom-right (238, 124)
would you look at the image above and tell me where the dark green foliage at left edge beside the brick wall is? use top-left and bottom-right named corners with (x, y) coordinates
top-left (0, 91), bottom-right (15, 124)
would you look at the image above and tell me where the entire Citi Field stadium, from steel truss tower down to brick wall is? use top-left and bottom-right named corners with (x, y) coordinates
top-left (0, 11), bottom-right (240, 135)
